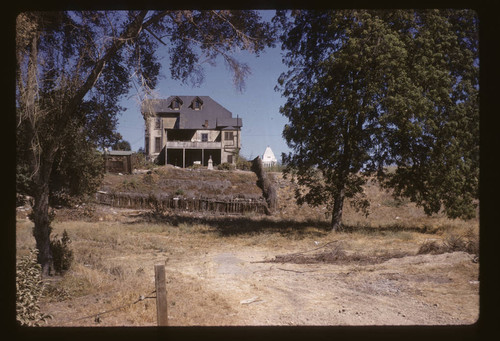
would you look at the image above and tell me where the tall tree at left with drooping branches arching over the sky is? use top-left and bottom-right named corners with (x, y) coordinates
top-left (16, 10), bottom-right (273, 275)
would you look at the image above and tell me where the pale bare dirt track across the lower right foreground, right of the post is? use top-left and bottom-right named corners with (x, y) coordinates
top-left (163, 243), bottom-right (479, 325)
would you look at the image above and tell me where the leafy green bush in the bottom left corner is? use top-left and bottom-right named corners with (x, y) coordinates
top-left (16, 249), bottom-right (52, 326)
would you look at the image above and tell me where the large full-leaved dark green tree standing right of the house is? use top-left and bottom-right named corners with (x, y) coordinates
top-left (275, 10), bottom-right (479, 229)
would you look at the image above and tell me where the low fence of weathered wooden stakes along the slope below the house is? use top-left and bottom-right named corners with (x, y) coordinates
top-left (96, 191), bottom-right (267, 214)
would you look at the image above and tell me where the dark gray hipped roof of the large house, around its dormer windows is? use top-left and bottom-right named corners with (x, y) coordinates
top-left (141, 96), bottom-right (243, 129)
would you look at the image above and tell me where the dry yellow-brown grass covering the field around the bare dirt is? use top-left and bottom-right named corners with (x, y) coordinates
top-left (16, 169), bottom-right (479, 326)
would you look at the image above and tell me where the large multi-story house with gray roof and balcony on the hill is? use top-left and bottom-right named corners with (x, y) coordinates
top-left (141, 96), bottom-right (242, 168)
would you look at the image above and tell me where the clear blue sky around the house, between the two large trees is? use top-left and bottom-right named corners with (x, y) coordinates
top-left (118, 11), bottom-right (290, 160)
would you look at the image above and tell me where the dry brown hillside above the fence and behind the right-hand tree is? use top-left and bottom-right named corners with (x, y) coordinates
top-left (97, 166), bottom-right (478, 234)
